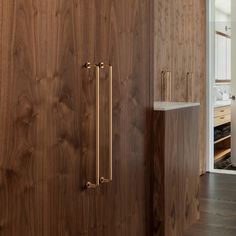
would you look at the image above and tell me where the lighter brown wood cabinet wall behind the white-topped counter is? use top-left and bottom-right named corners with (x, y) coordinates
top-left (153, 0), bottom-right (206, 174)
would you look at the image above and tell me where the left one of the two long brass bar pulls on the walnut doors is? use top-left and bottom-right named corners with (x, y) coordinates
top-left (85, 62), bottom-right (100, 189)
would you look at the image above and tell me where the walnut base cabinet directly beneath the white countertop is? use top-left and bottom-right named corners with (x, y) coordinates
top-left (153, 108), bottom-right (199, 236)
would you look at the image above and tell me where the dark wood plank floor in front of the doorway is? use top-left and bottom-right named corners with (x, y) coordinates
top-left (185, 174), bottom-right (236, 236)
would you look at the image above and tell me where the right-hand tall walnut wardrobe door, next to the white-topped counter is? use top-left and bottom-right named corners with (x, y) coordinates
top-left (95, 0), bottom-right (153, 236)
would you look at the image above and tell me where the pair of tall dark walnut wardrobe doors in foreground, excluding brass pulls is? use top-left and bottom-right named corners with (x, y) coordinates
top-left (0, 0), bottom-right (153, 236)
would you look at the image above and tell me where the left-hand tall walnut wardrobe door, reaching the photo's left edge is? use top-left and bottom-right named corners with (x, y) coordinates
top-left (0, 0), bottom-right (99, 236)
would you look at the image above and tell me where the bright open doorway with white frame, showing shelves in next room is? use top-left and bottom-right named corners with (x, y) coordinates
top-left (207, 0), bottom-right (236, 174)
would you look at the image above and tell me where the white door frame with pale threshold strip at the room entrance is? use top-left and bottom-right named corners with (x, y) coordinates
top-left (206, 0), bottom-right (236, 175)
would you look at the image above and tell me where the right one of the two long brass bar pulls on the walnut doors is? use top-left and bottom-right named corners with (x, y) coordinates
top-left (99, 63), bottom-right (112, 184)
